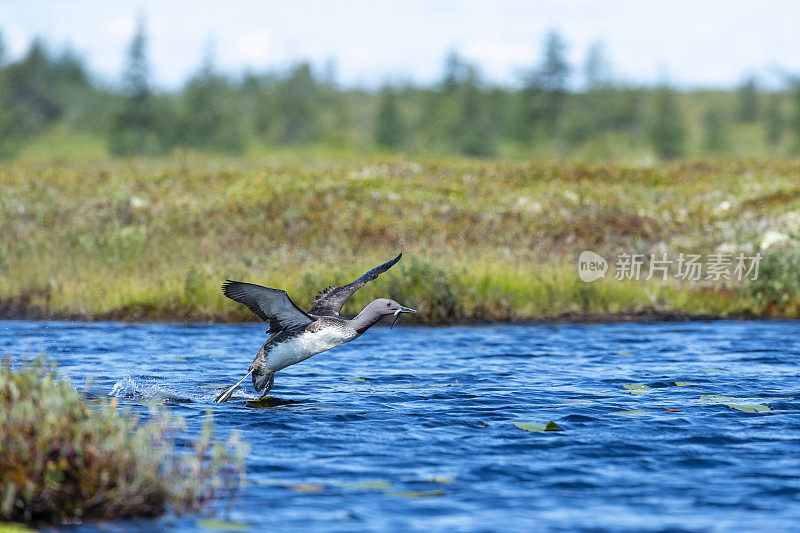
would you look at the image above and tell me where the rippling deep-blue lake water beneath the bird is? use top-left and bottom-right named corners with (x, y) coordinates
top-left (0, 321), bottom-right (800, 532)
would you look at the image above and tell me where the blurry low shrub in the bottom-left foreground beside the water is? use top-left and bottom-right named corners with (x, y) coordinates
top-left (0, 359), bottom-right (243, 529)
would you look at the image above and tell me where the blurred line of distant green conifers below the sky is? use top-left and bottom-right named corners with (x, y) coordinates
top-left (0, 23), bottom-right (800, 159)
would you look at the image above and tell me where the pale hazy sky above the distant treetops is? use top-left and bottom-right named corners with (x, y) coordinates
top-left (0, 0), bottom-right (800, 89)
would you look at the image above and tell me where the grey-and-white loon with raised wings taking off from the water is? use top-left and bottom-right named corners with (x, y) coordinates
top-left (214, 254), bottom-right (416, 402)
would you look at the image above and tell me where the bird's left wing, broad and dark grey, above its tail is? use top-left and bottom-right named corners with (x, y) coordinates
top-left (222, 280), bottom-right (314, 333)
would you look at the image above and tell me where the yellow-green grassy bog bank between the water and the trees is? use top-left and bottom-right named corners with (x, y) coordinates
top-left (0, 153), bottom-right (800, 323)
